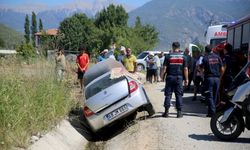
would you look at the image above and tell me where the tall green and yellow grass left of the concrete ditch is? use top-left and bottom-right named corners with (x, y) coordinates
top-left (0, 59), bottom-right (75, 149)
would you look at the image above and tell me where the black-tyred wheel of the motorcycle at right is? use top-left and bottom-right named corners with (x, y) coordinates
top-left (210, 111), bottom-right (244, 141)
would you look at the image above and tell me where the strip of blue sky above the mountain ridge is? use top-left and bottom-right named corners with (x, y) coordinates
top-left (0, 0), bottom-right (150, 7)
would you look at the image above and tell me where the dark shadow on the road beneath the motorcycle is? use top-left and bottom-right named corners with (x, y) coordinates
top-left (188, 133), bottom-right (250, 144)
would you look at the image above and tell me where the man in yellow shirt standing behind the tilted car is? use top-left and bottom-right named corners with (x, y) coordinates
top-left (123, 48), bottom-right (136, 73)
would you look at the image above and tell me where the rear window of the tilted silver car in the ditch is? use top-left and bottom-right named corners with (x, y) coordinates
top-left (85, 74), bottom-right (125, 100)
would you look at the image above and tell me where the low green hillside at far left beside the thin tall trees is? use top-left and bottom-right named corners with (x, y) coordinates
top-left (0, 24), bottom-right (24, 49)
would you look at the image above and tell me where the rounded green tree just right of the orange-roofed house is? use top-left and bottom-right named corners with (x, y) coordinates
top-left (59, 13), bottom-right (101, 50)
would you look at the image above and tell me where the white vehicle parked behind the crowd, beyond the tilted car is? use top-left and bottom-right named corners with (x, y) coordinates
top-left (136, 51), bottom-right (169, 72)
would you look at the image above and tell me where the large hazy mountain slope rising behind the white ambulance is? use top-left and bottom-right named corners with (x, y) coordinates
top-left (129, 0), bottom-right (250, 50)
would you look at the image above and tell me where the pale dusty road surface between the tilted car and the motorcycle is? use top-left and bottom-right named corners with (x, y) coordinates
top-left (84, 83), bottom-right (250, 150)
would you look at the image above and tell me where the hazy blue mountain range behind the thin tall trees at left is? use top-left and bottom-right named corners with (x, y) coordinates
top-left (0, 0), bottom-right (124, 32)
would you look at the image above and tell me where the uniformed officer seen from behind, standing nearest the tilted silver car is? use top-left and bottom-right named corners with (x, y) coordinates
top-left (161, 42), bottom-right (188, 118)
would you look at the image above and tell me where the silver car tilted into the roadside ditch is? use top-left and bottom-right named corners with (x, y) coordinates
top-left (83, 59), bottom-right (155, 133)
